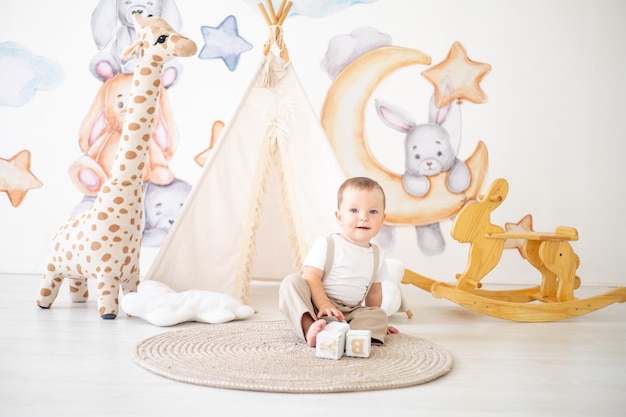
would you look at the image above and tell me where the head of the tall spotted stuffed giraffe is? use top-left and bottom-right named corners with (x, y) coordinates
top-left (121, 13), bottom-right (198, 64)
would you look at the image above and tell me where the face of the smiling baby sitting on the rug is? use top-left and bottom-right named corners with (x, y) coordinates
top-left (336, 188), bottom-right (385, 248)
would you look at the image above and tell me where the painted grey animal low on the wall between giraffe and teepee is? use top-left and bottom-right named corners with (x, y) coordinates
top-left (142, 179), bottom-right (191, 247)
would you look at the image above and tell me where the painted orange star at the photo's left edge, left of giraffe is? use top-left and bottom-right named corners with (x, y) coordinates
top-left (0, 150), bottom-right (43, 207)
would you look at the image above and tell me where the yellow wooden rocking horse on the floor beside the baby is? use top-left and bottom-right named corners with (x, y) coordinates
top-left (402, 178), bottom-right (626, 322)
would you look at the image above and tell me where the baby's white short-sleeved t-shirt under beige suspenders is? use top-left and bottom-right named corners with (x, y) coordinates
top-left (303, 234), bottom-right (390, 305)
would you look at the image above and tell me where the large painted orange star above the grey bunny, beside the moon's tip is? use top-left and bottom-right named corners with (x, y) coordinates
top-left (422, 42), bottom-right (491, 108)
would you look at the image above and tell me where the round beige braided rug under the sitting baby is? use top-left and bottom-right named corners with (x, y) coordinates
top-left (133, 321), bottom-right (452, 393)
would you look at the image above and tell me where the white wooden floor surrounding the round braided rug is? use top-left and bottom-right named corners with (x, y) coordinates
top-left (0, 275), bottom-right (626, 417)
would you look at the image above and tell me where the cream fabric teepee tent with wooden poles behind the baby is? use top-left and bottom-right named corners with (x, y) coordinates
top-left (145, 2), bottom-right (345, 302)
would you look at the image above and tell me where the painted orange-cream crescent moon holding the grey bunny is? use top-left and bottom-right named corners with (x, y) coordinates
top-left (321, 46), bottom-right (488, 226)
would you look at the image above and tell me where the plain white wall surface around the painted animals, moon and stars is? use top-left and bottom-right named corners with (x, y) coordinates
top-left (0, 0), bottom-right (626, 285)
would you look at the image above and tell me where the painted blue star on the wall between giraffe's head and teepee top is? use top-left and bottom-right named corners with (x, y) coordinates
top-left (198, 15), bottom-right (252, 72)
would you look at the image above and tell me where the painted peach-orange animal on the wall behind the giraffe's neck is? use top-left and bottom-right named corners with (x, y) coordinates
top-left (69, 61), bottom-right (178, 196)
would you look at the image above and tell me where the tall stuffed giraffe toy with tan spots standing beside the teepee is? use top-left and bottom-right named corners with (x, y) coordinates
top-left (37, 14), bottom-right (197, 319)
